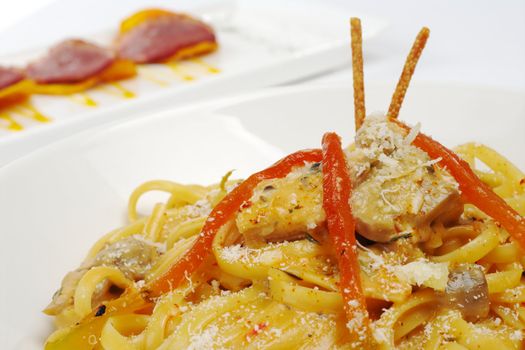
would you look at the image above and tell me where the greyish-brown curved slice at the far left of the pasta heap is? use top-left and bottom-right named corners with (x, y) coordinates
top-left (44, 237), bottom-right (159, 315)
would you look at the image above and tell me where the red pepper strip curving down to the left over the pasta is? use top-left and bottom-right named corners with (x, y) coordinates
top-left (147, 149), bottom-right (322, 296)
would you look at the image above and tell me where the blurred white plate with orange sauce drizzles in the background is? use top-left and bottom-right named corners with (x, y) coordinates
top-left (0, 0), bottom-right (385, 166)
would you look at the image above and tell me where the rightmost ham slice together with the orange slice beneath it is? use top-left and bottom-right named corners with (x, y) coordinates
top-left (116, 10), bottom-right (217, 63)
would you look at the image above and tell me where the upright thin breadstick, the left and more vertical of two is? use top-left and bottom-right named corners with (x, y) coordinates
top-left (350, 17), bottom-right (366, 131)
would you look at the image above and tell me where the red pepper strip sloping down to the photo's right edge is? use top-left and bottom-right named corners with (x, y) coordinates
top-left (394, 120), bottom-right (525, 250)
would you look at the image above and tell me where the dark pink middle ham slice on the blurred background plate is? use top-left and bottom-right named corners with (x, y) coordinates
top-left (26, 39), bottom-right (115, 84)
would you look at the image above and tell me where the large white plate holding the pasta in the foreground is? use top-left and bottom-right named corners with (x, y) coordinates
top-left (0, 84), bottom-right (525, 349)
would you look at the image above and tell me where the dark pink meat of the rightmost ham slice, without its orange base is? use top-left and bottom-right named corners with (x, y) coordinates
top-left (117, 13), bottom-right (216, 63)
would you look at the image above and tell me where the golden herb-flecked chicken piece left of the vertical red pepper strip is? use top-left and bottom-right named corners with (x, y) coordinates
top-left (236, 163), bottom-right (325, 245)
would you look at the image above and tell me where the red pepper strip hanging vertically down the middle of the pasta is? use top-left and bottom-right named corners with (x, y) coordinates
top-left (323, 133), bottom-right (370, 348)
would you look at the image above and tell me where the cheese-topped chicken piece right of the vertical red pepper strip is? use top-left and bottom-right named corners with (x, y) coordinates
top-left (347, 116), bottom-right (463, 242)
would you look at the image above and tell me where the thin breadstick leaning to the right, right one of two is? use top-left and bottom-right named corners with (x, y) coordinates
top-left (387, 27), bottom-right (430, 119)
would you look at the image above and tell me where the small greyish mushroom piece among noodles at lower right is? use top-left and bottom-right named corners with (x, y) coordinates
top-left (445, 264), bottom-right (490, 322)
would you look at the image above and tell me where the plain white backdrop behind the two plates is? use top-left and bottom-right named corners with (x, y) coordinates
top-left (0, 0), bottom-right (525, 91)
